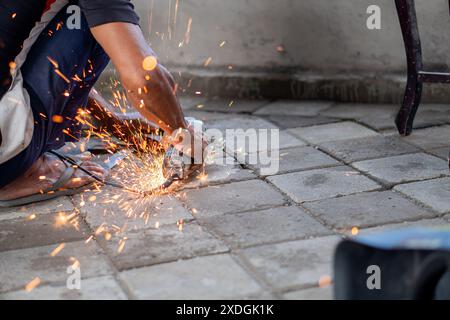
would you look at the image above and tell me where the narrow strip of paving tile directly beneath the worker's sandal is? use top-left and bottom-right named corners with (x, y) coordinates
top-left (0, 197), bottom-right (74, 221)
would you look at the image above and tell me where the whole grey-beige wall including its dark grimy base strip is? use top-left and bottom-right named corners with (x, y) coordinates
top-left (103, 0), bottom-right (450, 101)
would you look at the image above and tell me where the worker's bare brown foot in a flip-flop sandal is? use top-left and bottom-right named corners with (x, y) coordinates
top-left (0, 153), bottom-right (108, 200)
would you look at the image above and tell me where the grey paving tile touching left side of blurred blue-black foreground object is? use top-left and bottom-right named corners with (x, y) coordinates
top-left (241, 236), bottom-right (340, 289)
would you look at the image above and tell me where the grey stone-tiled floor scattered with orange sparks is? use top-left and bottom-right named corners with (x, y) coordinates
top-left (0, 98), bottom-right (450, 299)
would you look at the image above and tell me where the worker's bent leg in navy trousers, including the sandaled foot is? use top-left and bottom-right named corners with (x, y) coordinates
top-left (0, 8), bottom-right (109, 199)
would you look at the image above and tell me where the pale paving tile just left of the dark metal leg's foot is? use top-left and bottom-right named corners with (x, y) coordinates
top-left (288, 121), bottom-right (378, 144)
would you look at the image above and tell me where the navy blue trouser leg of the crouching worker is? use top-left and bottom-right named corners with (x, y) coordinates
top-left (0, 8), bottom-right (109, 188)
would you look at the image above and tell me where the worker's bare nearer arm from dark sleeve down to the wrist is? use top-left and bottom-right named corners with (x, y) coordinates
top-left (91, 22), bottom-right (186, 134)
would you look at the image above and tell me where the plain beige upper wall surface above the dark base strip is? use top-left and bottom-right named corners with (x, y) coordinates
top-left (134, 0), bottom-right (450, 74)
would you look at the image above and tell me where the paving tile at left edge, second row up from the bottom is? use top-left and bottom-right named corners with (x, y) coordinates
top-left (0, 241), bottom-right (113, 292)
